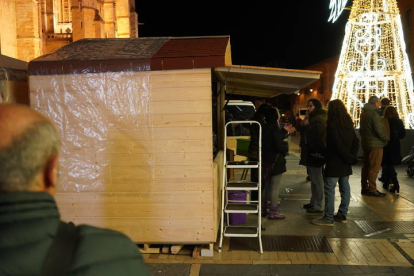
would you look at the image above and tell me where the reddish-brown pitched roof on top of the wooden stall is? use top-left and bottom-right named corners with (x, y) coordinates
top-left (29, 36), bottom-right (231, 75)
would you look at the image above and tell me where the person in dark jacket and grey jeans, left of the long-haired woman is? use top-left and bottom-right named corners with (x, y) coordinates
top-left (299, 98), bottom-right (326, 213)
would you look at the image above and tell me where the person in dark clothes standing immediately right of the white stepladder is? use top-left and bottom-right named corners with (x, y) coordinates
top-left (262, 108), bottom-right (294, 219)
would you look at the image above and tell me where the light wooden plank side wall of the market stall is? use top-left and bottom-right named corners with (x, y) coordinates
top-left (30, 69), bottom-right (217, 244)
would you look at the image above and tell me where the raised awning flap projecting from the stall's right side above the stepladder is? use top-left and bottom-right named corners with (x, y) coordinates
top-left (213, 65), bottom-right (322, 98)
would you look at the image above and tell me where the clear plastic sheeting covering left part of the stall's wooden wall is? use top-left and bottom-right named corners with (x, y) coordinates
top-left (30, 71), bottom-right (154, 192)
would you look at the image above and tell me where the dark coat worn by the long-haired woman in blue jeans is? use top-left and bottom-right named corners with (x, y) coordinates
top-left (325, 123), bottom-right (359, 177)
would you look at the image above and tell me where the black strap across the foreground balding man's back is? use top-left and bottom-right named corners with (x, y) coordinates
top-left (40, 221), bottom-right (78, 276)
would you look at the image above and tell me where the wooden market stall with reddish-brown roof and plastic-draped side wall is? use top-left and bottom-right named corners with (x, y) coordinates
top-left (29, 36), bottom-right (319, 244)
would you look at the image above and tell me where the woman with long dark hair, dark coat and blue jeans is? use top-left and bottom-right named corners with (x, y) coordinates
top-left (312, 100), bottom-right (359, 226)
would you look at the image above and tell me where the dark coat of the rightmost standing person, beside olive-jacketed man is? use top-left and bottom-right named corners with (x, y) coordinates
top-left (382, 119), bottom-right (405, 166)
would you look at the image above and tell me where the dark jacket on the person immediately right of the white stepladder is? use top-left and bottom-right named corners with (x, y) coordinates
top-left (262, 124), bottom-right (289, 175)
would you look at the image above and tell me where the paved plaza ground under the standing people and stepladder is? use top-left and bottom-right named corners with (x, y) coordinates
top-left (145, 136), bottom-right (414, 276)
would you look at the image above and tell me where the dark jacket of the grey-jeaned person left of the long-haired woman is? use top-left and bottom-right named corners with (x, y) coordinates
top-left (299, 108), bottom-right (327, 167)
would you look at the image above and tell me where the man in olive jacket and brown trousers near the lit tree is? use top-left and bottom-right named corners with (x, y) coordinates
top-left (360, 96), bottom-right (388, 197)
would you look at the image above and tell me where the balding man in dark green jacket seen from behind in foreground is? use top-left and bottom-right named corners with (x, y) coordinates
top-left (0, 105), bottom-right (149, 276)
